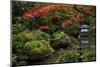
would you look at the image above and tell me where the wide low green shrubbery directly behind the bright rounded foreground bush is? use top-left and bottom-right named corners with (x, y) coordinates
top-left (13, 30), bottom-right (50, 43)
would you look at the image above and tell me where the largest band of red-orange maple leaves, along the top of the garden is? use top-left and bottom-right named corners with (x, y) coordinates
top-left (23, 4), bottom-right (59, 18)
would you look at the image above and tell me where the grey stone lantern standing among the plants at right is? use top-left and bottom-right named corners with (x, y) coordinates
top-left (79, 24), bottom-right (91, 48)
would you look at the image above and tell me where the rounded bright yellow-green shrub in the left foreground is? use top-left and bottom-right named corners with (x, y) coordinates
top-left (24, 40), bottom-right (54, 60)
